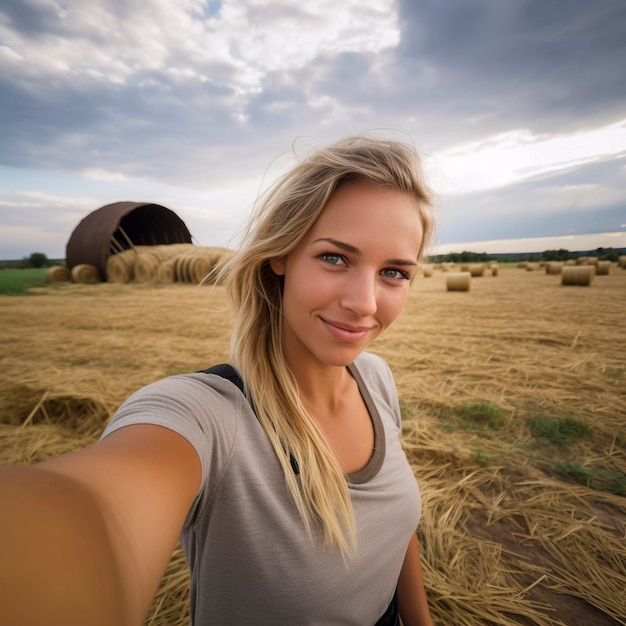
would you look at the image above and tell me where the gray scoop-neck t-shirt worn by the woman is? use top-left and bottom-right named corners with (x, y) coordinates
top-left (103, 353), bottom-right (421, 626)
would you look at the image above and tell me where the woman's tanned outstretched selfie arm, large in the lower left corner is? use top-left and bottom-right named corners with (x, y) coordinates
top-left (0, 425), bottom-right (200, 626)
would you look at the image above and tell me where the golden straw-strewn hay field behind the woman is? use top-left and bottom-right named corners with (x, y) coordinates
top-left (0, 266), bottom-right (626, 626)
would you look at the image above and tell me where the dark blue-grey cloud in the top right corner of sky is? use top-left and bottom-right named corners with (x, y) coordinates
top-left (397, 0), bottom-right (626, 143)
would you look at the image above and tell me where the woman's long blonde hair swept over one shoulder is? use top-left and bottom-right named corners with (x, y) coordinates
top-left (224, 135), bottom-right (433, 557)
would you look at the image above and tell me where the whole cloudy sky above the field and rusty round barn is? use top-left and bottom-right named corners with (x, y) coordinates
top-left (0, 0), bottom-right (626, 259)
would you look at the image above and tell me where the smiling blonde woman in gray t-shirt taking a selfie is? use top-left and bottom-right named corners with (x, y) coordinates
top-left (0, 136), bottom-right (432, 626)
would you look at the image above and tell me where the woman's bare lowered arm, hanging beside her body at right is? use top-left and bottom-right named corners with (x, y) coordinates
top-left (398, 534), bottom-right (433, 626)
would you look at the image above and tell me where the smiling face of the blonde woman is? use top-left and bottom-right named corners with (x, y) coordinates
top-left (271, 180), bottom-right (423, 369)
